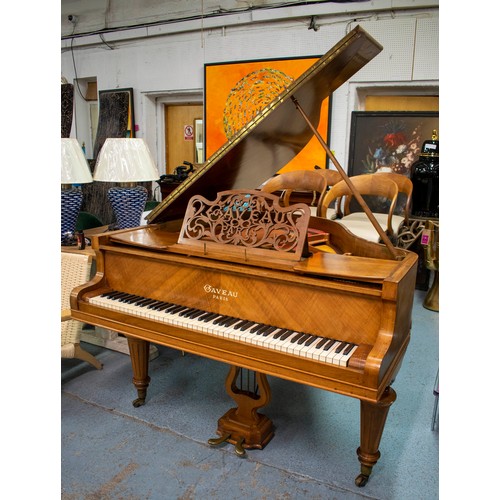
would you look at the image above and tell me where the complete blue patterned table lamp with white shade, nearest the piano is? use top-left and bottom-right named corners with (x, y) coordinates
top-left (94, 139), bottom-right (160, 229)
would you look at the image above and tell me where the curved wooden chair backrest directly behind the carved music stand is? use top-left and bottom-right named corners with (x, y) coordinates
top-left (260, 170), bottom-right (328, 207)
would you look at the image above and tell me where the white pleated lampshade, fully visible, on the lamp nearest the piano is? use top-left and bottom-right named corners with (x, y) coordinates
top-left (94, 139), bottom-right (160, 182)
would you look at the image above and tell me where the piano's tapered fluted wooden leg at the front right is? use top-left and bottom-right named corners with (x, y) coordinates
top-left (356, 387), bottom-right (396, 487)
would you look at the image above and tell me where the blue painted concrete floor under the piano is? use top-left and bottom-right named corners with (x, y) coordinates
top-left (61, 291), bottom-right (439, 500)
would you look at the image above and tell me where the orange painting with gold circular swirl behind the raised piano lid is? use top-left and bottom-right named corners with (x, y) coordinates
top-left (204, 57), bottom-right (330, 172)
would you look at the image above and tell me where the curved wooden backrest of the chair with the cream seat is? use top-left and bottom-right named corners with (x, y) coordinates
top-left (319, 174), bottom-right (398, 233)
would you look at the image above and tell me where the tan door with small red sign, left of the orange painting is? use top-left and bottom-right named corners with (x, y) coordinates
top-left (164, 104), bottom-right (203, 174)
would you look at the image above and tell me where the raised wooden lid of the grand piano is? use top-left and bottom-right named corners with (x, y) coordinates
top-left (147, 26), bottom-right (382, 223)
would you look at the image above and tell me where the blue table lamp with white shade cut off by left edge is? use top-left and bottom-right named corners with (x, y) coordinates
top-left (61, 138), bottom-right (92, 244)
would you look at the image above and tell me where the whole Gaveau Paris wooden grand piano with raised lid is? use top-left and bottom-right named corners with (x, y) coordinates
top-left (71, 27), bottom-right (417, 486)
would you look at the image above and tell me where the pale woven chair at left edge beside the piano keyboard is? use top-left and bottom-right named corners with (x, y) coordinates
top-left (61, 252), bottom-right (102, 370)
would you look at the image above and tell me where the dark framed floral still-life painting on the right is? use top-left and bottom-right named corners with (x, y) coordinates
top-left (348, 111), bottom-right (439, 177)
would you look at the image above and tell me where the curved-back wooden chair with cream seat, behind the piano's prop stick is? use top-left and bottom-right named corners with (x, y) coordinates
top-left (319, 174), bottom-right (398, 242)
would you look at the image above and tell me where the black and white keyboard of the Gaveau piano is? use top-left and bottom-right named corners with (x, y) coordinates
top-left (89, 291), bottom-right (357, 366)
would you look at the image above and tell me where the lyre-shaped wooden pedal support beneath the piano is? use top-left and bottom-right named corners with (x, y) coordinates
top-left (208, 366), bottom-right (274, 457)
